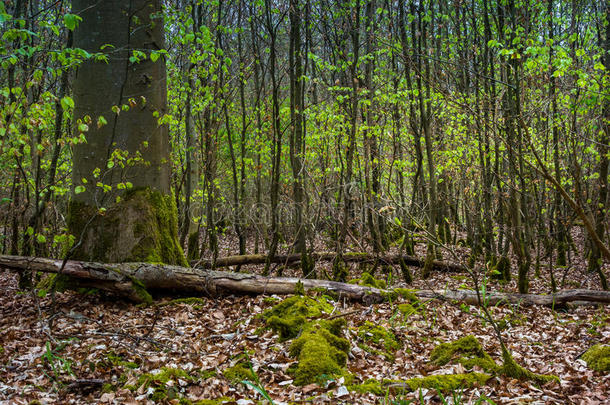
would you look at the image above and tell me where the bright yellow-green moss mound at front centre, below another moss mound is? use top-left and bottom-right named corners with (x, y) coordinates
top-left (289, 318), bottom-right (350, 385)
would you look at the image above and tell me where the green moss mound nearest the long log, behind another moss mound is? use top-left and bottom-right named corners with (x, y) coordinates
top-left (263, 296), bottom-right (333, 342)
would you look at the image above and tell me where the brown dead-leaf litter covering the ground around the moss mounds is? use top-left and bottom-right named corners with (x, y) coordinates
top-left (0, 232), bottom-right (610, 405)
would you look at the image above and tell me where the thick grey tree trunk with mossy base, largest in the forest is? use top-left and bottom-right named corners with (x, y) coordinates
top-left (68, 0), bottom-right (185, 264)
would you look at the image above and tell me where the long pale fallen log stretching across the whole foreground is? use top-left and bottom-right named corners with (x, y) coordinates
top-left (0, 256), bottom-right (610, 306)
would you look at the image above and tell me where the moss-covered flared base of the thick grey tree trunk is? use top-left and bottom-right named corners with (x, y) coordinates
top-left (68, 188), bottom-right (187, 266)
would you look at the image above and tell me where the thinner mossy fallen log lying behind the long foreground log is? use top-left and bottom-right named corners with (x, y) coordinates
top-left (190, 252), bottom-right (468, 273)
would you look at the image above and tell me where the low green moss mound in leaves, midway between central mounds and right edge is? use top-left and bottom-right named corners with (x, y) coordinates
top-left (430, 335), bottom-right (498, 373)
